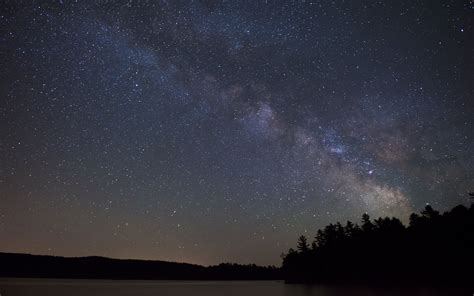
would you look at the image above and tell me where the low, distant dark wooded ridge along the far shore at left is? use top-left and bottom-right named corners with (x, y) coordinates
top-left (0, 253), bottom-right (282, 280)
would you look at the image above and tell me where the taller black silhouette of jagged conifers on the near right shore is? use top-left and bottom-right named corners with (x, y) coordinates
top-left (282, 205), bottom-right (474, 287)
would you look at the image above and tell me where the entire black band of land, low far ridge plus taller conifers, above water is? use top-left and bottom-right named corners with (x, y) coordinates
top-left (0, 205), bottom-right (474, 287)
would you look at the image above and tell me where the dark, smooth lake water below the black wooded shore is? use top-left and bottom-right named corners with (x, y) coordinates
top-left (0, 278), bottom-right (466, 296)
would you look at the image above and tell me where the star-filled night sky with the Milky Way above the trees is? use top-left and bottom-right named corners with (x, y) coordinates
top-left (0, 0), bottom-right (474, 265)
